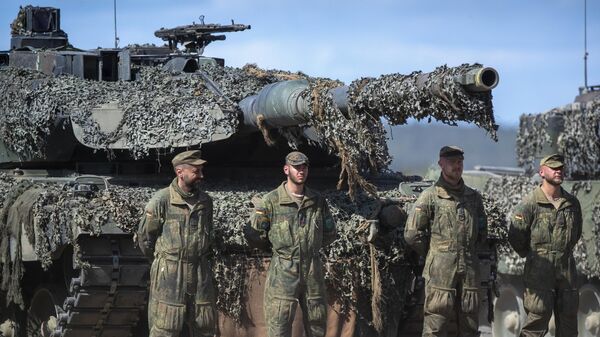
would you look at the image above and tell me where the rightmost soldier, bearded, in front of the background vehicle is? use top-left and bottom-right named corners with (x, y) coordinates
top-left (508, 154), bottom-right (582, 337)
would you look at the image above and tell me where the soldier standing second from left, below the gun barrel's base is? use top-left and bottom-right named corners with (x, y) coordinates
top-left (246, 151), bottom-right (336, 337)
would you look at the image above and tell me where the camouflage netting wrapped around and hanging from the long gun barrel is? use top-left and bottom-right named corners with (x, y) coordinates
top-left (306, 64), bottom-right (498, 195)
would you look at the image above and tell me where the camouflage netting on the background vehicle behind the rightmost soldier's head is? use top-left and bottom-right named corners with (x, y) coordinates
top-left (517, 100), bottom-right (600, 179)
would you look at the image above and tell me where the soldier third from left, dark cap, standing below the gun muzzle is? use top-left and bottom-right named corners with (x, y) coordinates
top-left (404, 146), bottom-right (487, 337)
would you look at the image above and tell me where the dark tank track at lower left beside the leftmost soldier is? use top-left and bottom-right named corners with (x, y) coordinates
top-left (52, 234), bottom-right (150, 337)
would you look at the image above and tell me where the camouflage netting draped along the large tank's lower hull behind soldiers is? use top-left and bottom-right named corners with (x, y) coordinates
top-left (0, 174), bottom-right (422, 330)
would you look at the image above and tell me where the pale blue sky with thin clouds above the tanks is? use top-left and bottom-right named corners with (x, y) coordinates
top-left (0, 0), bottom-right (600, 127)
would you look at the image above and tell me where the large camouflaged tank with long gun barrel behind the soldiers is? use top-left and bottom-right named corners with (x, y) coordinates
top-left (0, 6), bottom-right (499, 337)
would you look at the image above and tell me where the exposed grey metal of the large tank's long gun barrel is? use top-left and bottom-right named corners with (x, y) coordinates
top-left (240, 67), bottom-right (499, 128)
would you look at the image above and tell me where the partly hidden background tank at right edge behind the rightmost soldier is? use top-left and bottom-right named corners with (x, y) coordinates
top-left (474, 86), bottom-right (600, 337)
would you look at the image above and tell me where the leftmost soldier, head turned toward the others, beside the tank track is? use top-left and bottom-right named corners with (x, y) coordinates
top-left (138, 150), bottom-right (217, 337)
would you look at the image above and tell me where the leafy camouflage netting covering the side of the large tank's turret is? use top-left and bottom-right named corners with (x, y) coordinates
top-left (0, 67), bottom-right (238, 158)
